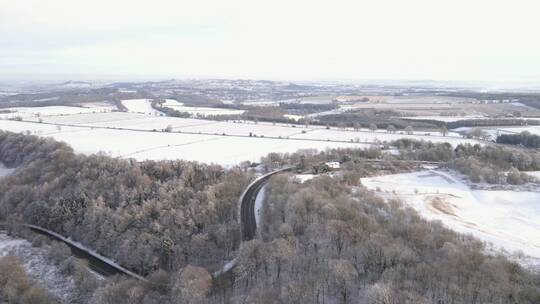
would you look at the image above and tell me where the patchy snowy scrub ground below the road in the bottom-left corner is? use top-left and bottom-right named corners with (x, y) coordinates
top-left (0, 232), bottom-right (78, 303)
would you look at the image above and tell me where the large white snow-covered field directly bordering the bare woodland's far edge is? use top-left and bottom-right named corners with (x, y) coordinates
top-left (0, 120), bottom-right (369, 165)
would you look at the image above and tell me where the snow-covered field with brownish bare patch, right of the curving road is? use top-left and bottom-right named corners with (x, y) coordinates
top-left (361, 170), bottom-right (540, 267)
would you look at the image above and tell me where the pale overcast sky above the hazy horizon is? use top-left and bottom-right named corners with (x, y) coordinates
top-left (0, 0), bottom-right (540, 81)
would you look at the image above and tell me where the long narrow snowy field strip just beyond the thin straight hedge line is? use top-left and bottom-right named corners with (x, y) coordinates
top-left (20, 112), bottom-right (477, 144)
